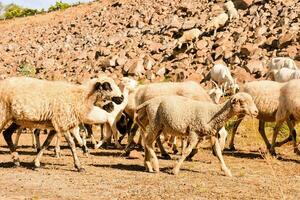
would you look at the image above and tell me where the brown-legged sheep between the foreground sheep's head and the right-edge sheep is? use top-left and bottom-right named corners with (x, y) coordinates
top-left (229, 80), bottom-right (292, 153)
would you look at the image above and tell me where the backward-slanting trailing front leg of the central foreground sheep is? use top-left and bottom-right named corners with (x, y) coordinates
top-left (173, 131), bottom-right (198, 175)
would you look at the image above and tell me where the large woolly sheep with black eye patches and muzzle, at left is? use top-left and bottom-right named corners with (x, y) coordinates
top-left (0, 76), bottom-right (123, 171)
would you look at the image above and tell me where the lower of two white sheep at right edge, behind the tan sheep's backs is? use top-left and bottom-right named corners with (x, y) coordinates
top-left (271, 68), bottom-right (300, 82)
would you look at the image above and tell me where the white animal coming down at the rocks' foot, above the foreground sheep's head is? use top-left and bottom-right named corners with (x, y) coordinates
top-left (210, 64), bottom-right (239, 94)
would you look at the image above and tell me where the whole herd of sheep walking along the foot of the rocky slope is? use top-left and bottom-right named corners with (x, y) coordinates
top-left (0, 57), bottom-right (300, 176)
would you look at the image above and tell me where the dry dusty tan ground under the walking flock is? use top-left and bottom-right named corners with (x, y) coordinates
top-left (0, 120), bottom-right (300, 199)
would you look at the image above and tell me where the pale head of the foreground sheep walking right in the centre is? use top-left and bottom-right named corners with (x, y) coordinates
top-left (230, 92), bottom-right (258, 117)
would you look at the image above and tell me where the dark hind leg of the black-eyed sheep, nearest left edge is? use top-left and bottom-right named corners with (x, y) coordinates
top-left (3, 123), bottom-right (20, 166)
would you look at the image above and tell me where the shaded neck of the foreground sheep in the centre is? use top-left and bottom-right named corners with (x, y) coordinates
top-left (208, 100), bottom-right (234, 130)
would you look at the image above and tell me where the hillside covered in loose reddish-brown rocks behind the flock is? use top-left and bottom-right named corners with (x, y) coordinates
top-left (0, 0), bottom-right (300, 85)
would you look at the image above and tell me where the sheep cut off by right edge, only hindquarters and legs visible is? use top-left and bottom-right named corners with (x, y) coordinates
top-left (271, 79), bottom-right (300, 155)
